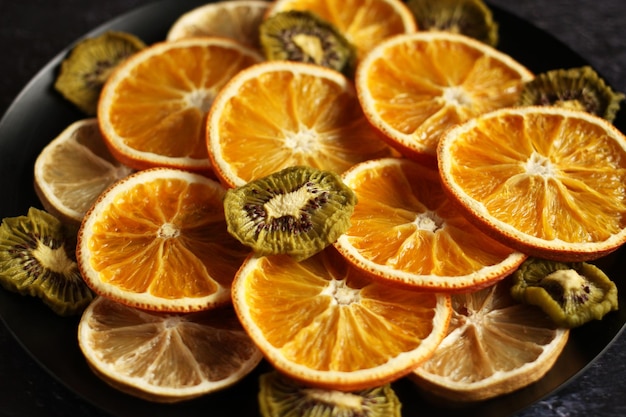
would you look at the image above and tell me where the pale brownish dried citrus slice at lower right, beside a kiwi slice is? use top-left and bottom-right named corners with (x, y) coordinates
top-left (411, 279), bottom-right (569, 402)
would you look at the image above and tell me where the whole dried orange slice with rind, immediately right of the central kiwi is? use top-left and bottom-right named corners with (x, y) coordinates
top-left (335, 158), bottom-right (526, 291)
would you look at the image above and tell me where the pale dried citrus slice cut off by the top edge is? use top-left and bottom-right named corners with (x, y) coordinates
top-left (166, 0), bottom-right (271, 50)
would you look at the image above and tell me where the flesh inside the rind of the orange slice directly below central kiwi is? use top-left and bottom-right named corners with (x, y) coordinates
top-left (240, 254), bottom-right (437, 372)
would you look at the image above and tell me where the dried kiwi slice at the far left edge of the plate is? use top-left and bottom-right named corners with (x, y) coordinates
top-left (0, 207), bottom-right (94, 316)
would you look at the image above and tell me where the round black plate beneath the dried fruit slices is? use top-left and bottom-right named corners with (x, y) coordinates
top-left (0, 0), bottom-right (626, 417)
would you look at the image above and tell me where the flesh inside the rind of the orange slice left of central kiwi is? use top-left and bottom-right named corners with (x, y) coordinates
top-left (88, 179), bottom-right (245, 299)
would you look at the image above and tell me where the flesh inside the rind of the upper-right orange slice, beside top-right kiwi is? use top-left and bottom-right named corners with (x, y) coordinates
top-left (368, 40), bottom-right (522, 149)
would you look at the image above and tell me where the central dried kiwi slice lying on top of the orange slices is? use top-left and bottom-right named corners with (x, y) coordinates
top-left (224, 166), bottom-right (356, 261)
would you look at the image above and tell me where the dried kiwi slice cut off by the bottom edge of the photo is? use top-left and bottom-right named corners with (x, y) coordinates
top-left (259, 371), bottom-right (402, 417)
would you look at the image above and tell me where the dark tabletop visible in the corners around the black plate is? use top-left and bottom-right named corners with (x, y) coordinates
top-left (0, 0), bottom-right (626, 417)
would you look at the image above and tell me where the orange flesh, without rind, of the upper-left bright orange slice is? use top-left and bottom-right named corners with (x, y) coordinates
top-left (108, 46), bottom-right (256, 159)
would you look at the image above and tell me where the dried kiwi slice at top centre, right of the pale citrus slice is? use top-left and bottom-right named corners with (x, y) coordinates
top-left (259, 10), bottom-right (356, 76)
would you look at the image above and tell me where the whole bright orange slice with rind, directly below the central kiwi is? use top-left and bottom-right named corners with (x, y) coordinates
top-left (233, 246), bottom-right (451, 391)
